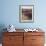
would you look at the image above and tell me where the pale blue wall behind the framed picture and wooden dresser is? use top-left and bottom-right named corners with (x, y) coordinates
top-left (0, 0), bottom-right (46, 28)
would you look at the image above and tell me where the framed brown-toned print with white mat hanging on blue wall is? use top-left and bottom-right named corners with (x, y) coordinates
top-left (19, 5), bottom-right (34, 22)
